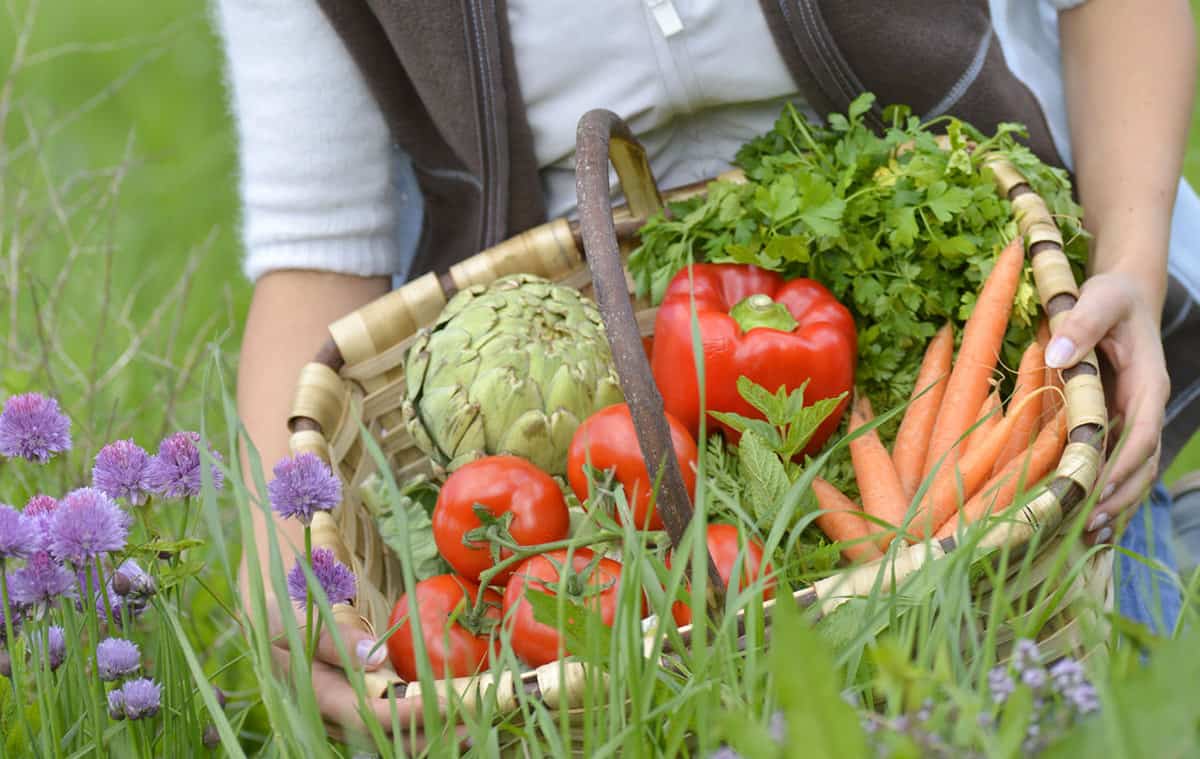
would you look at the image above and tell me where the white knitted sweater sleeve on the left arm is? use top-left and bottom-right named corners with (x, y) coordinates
top-left (216, 0), bottom-right (413, 281)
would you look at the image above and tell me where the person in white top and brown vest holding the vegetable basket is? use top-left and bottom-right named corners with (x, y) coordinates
top-left (220, 0), bottom-right (1200, 739)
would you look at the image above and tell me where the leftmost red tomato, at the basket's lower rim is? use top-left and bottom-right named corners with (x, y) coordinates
top-left (388, 574), bottom-right (502, 682)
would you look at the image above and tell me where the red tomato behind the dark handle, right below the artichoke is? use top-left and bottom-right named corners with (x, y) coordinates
top-left (566, 404), bottom-right (697, 530)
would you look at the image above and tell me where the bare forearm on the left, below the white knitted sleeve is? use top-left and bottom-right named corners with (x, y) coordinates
top-left (238, 270), bottom-right (390, 593)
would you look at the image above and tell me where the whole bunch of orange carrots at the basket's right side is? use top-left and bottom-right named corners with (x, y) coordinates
top-left (814, 239), bottom-right (1067, 561)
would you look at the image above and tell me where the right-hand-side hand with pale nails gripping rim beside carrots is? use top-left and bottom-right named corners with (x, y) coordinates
top-left (1046, 271), bottom-right (1170, 544)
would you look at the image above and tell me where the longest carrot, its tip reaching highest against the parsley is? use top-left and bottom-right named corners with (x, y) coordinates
top-left (923, 238), bottom-right (1025, 477)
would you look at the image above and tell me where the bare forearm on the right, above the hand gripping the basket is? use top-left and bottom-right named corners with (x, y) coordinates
top-left (1060, 0), bottom-right (1195, 315)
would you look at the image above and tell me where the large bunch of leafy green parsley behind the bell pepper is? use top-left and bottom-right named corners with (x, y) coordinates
top-left (629, 95), bottom-right (1087, 440)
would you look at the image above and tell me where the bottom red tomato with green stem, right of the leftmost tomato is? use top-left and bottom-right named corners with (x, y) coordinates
top-left (504, 548), bottom-right (620, 667)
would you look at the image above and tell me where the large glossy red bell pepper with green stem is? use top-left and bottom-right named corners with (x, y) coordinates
top-left (650, 264), bottom-right (858, 454)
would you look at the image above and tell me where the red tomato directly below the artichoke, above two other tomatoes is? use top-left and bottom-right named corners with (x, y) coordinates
top-left (433, 456), bottom-right (571, 585)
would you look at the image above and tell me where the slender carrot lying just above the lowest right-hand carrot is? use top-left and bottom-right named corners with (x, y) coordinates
top-left (908, 398), bottom-right (1039, 538)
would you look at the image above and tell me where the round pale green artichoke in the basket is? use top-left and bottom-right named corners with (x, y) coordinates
top-left (402, 274), bottom-right (623, 474)
